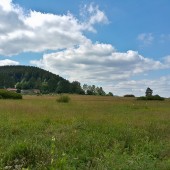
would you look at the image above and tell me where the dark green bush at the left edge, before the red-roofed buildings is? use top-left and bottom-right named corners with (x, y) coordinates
top-left (0, 89), bottom-right (22, 99)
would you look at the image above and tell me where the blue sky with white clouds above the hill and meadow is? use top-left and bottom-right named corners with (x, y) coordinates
top-left (0, 0), bottom-right (170, 97)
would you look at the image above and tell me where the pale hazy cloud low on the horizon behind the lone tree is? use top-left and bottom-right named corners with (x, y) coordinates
top-left (105, 76), bottom-right (170, 97)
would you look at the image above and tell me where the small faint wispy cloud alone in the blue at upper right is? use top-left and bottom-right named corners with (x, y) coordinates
top-left (137, 33), bottom-right (154, 46)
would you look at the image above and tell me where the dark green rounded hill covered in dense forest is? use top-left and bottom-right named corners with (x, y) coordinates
top-left (0, 66), bottom-right (84, 93)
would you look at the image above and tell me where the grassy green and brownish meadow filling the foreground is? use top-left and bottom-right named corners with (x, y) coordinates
top-left (0, 95), bottom-right (170, 170)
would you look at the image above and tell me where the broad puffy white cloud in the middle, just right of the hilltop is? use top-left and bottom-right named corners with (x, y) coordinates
top-left (31, 42), bottom-right (166, 83)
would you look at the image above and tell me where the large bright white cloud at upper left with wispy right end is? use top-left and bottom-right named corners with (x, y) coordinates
top-left (0, 0), bottom-right (107, 56)
